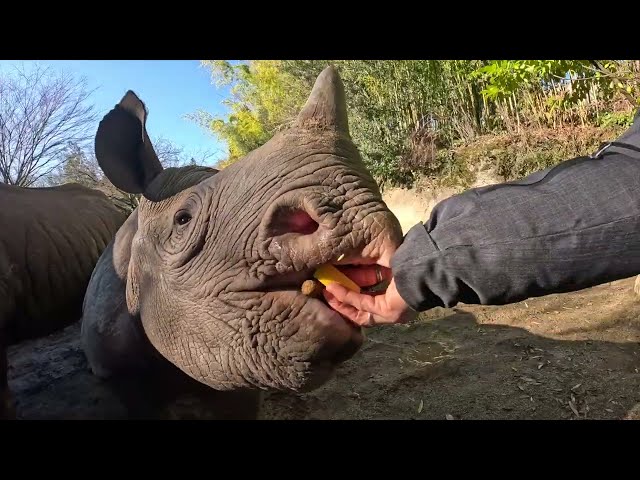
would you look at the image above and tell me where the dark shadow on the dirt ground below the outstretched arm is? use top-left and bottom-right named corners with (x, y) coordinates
top-left (264, 311), bottom-right (640, 419)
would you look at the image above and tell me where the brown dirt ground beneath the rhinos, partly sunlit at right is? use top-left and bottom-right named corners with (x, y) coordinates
top-left (9, 279), bottom-right (640, 419)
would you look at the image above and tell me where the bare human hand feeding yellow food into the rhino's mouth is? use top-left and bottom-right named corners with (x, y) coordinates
top-left (323, 267), bottom-right (417, 327)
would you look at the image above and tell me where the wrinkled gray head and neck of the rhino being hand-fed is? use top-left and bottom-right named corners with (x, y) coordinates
top-left (82, 67), bottom-right (402, 418)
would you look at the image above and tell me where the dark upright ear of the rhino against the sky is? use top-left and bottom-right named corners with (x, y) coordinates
top-left (95, 90), bottom-right (162, 193)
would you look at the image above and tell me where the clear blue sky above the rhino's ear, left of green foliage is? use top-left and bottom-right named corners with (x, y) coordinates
top-left (0, 60), bottom-right (229, 163)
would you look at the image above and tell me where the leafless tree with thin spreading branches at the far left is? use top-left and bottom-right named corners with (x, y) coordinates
top-left (0, 66), bottom-right (96, 186)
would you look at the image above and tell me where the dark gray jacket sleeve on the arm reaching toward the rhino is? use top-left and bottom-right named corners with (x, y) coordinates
top-left (391, 154), bottom-right (640, 311)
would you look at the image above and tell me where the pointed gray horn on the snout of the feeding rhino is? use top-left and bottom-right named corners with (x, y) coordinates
top-left (295, 65), bottom-right (349, 135)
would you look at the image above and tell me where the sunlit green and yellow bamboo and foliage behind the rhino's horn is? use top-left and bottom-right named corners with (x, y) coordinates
top-left (194, 60), bottom-right (640, 186)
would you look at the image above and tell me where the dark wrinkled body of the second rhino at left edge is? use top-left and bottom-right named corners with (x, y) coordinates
top-left (0, 184), bottom-right (126, 418)
